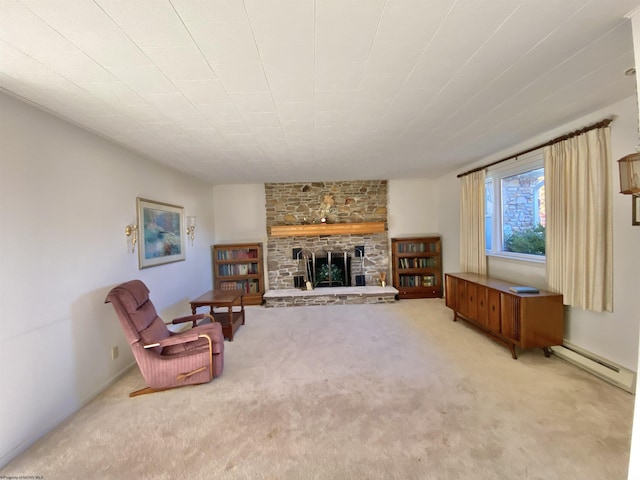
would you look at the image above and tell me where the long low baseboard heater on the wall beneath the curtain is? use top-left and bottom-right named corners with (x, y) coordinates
top-left (552, 341), bottom-right (636, 393)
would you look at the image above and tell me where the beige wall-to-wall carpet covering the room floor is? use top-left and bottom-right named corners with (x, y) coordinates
top-left (0, 299), bottom-right (634, 480)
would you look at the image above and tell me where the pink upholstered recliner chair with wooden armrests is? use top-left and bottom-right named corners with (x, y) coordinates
top-left (105, 280), bottom-right (224, 397)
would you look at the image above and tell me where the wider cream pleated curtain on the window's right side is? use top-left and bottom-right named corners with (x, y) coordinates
top-left (544, 127), bottom-right (613, 312)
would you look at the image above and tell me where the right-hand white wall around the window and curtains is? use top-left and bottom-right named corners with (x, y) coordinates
top-left (436, 96), bottom-right (640, 371)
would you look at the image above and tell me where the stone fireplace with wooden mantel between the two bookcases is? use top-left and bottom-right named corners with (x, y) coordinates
top-left (265, 180), bottom-right (390, 290)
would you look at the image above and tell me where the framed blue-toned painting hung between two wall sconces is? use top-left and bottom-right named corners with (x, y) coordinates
top-left (136, 197), bottom-right (186, 269)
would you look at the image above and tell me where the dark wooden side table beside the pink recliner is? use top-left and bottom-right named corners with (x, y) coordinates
top-left (189, 290), bottom-right (244, 342)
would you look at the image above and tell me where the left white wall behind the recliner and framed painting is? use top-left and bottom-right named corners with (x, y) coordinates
top-left (0, 94), bottom-right (213, 466)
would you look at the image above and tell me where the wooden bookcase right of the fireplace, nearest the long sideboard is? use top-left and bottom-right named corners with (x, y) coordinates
top-left (391, 235), bottom-right (443, 299)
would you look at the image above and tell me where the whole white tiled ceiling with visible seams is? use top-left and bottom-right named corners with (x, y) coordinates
top-left (0, 0), bottom-right (639, 183)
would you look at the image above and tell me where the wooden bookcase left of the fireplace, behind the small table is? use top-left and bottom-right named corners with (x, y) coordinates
top-left (212, 243), bottom-right (264, 305)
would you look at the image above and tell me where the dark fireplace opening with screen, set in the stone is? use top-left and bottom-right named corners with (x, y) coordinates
top-left (294, 248), bottom-right (365, 288)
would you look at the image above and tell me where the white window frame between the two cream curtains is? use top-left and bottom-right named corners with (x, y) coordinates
top-left (485, 148), bottom-right (547, 263)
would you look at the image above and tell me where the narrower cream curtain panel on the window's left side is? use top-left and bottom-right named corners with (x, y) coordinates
top-left (460, 169), bottom-right (487, 275)
